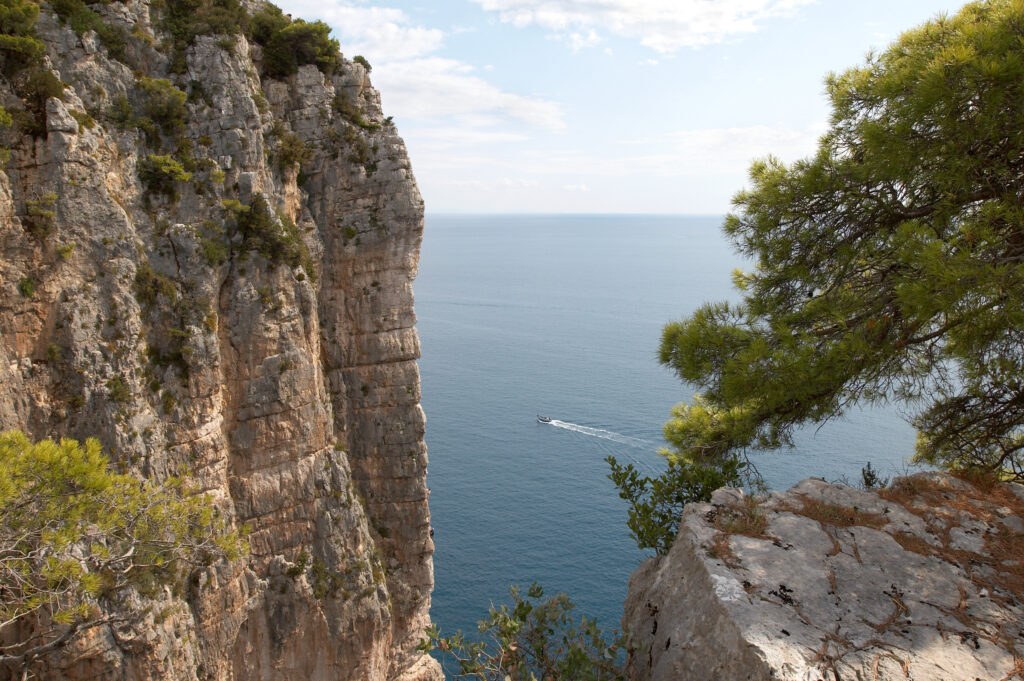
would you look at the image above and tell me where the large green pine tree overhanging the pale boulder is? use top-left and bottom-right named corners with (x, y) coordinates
top-left (613, 0), bottom-right (1024, 549)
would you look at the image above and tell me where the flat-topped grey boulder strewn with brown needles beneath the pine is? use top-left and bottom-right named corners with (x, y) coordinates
top-left (623, 473), bottom-right (1024, 681)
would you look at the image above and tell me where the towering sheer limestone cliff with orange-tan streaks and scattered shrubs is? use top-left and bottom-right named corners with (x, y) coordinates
top-left (0, 0), bottom-right (441, 681)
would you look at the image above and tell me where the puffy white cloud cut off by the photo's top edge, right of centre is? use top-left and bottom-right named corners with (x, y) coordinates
top-left (474, 0), bottom-right (816, 53)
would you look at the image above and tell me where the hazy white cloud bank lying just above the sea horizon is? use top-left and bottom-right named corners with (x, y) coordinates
top-left (417, 126), bottom-right (823, 213)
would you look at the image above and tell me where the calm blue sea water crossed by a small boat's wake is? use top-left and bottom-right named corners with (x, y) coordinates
top-left (415, 215), bottom-right (913, 655)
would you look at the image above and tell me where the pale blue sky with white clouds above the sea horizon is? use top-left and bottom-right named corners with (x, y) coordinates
top-left (276, 0), bottom-right (963, 215)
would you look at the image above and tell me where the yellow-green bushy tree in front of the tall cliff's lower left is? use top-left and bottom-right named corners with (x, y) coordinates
top-left (0, 431), bottom-right (244, 678)
